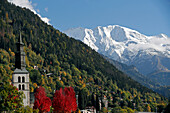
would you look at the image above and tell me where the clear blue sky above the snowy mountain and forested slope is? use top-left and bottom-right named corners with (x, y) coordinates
top-left (31, 0), bottom-right (170, 37)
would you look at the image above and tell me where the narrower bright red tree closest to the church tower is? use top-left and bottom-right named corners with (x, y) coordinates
top-left (33, 86), bottom-right (51, 113)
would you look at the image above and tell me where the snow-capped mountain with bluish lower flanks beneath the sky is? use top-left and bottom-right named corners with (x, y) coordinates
top-left (64, 25), bottom-right (170, 75)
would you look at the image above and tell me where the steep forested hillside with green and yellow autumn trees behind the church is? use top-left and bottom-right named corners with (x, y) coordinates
top-left (0, 0), bottom-right (167, 111)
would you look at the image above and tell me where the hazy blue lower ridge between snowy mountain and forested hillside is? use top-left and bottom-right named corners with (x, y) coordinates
top-left (104, 57), bottom-right (170, 97)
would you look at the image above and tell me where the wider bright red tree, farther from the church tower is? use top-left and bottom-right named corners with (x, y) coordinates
top-left (52, 87), bottom-right (77, 113)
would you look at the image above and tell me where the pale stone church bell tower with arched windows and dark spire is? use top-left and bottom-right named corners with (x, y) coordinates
top-left (12, 33), bottom-right (30, 106)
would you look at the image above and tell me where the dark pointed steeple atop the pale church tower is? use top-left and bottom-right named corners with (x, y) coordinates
top-left (15, 32), bottom-right (26, 69)
